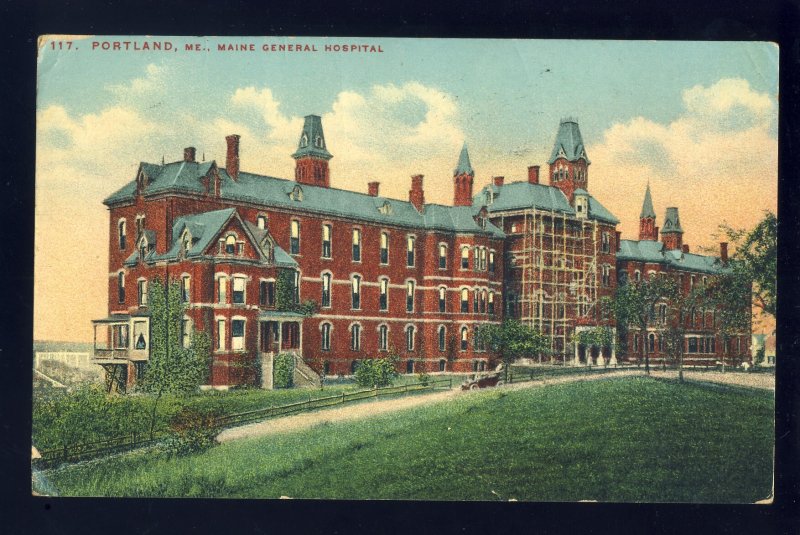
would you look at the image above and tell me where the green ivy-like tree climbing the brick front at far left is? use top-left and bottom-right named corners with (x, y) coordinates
top-left (140, 279), bottom-right (211, 436)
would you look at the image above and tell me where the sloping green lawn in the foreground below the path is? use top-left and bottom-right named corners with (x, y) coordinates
top-left (49, 378), bottom-right (774, 502)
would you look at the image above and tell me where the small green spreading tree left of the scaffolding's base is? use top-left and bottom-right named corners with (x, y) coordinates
top-left (475, 319), bottom-right (550, 380)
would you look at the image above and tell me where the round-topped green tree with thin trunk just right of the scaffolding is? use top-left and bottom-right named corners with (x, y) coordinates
top-left (608, 276), bottom-right (679, 375)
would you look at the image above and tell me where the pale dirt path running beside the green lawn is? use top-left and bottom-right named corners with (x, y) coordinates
top-left (217, 370), bottom-right (644, 442)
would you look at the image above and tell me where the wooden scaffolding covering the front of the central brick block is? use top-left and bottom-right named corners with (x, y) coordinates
top-left (511, 207), bottom-right (600, 363)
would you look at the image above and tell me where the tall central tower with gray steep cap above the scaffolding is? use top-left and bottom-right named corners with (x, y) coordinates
top-left (547, 118), bottom-right (591, 204)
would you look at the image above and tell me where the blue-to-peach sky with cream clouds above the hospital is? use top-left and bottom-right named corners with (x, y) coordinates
top-left (34, 36), bottom-right (778, 341)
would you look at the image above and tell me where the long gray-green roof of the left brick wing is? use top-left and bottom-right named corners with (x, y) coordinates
top-left (104, 161), bottom-right (504, 238)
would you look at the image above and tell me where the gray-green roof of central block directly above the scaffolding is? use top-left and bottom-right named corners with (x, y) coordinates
top-left (473, 181), bottom-right (619, 225)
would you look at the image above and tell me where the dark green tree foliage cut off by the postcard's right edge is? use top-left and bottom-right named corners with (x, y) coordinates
top-left (720, 212), bottom-right (778, 317)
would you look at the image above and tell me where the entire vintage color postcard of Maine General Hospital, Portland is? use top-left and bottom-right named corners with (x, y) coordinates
top-left (31, 35), bottom-right (778, 503)
